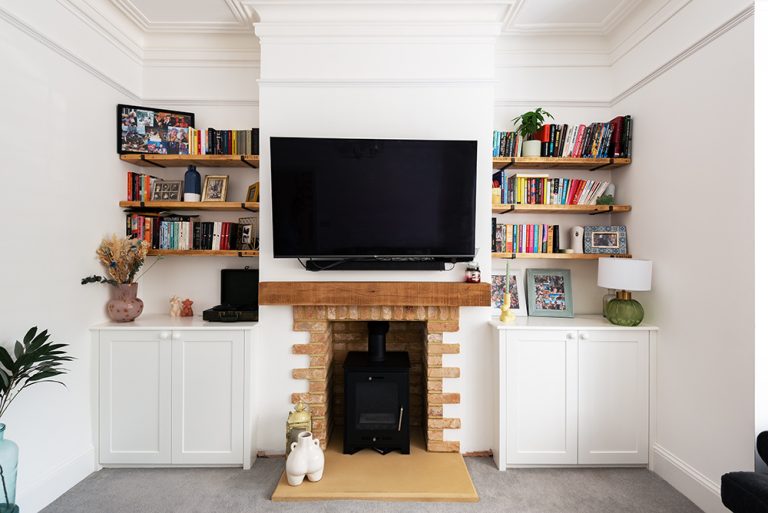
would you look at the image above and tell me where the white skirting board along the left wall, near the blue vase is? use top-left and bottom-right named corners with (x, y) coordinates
top-left (16, 446), bottom-right (96, 513)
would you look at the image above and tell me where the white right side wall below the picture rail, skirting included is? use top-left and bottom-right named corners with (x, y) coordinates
top-left (614, 12), bottom-right (755, 511)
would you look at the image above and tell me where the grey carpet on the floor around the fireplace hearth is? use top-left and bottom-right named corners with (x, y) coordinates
top-left (43, 458), bottom-right (701, 513)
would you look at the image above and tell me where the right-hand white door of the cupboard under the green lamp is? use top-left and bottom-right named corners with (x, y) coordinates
top-left (579, 330), bottom-right (649, 464)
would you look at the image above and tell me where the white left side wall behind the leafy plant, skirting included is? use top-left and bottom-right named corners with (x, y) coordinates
top-left (0, 1), bottom-right (140, 512)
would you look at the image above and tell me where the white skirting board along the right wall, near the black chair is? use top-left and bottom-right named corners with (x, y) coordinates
top-left (653, 444), bottom-right (729, 513)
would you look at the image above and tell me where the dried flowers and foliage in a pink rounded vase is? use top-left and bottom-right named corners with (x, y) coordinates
top-left (80, 235), bottom-right (149, 322)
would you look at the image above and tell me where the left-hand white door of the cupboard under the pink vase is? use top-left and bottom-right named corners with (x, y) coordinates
top-left (99, 330), bottom-right (171, 465)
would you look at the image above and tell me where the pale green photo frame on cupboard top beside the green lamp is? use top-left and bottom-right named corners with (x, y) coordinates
top-left (527, 269), bottom-right (573, 317)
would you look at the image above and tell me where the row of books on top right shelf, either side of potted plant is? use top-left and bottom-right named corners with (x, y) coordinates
top-left (493, 116), bottom-right (632, 158)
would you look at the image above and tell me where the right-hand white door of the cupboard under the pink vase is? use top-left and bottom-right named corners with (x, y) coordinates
top-left (172, 330), bottom-right (245, 464)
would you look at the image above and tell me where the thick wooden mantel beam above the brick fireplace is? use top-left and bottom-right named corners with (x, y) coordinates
top-left (259, 281), bottom-right (491, 306)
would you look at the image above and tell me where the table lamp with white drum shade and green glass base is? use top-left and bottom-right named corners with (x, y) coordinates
top-left (597, 258), bottom-right (653, 326)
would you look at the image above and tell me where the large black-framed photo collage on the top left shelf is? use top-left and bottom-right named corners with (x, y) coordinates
top-left (117, 104), bottom-right (195, 155)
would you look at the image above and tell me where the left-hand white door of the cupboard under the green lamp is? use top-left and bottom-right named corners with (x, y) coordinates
top-left (506, 330), bottom-right (577, 465)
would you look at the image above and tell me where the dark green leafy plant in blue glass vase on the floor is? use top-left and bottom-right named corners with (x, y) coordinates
top-left (0, 327), bottom-right (73, 513)
